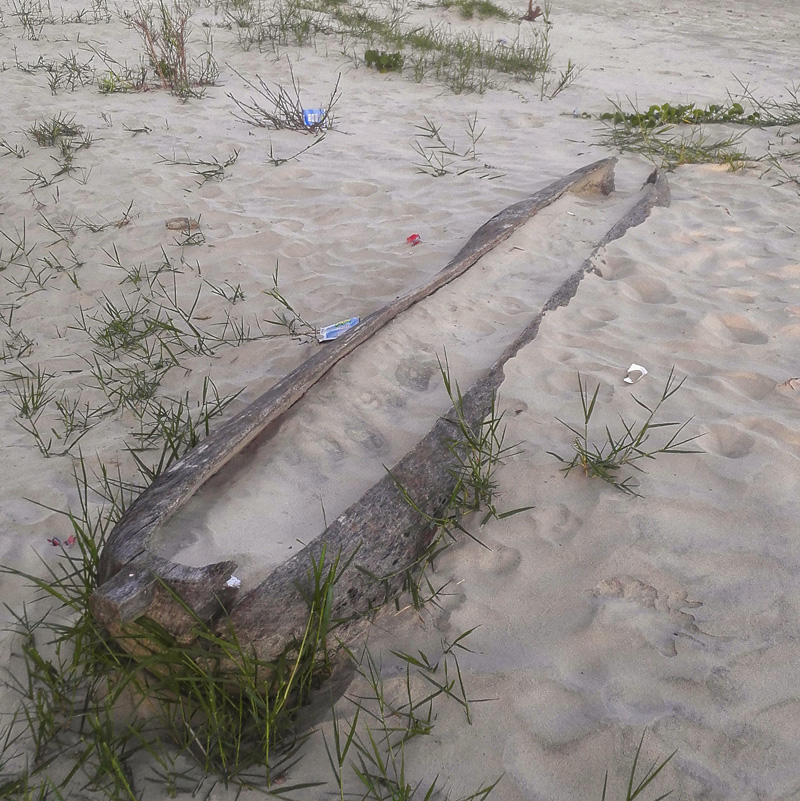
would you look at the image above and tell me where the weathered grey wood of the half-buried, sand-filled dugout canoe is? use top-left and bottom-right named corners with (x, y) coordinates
top-left (91, 159), bottom-right (669, 659)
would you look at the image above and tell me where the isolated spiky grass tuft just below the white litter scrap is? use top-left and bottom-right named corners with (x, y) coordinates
top-left (548, 367), bottom-right (702, 497)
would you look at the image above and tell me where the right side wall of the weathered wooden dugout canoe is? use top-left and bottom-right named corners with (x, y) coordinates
top-left (225, 167), bottom-right (669, 659)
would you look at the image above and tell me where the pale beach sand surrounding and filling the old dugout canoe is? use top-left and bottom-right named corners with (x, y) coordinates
top-left (0, 0), bottom-right (800, 801)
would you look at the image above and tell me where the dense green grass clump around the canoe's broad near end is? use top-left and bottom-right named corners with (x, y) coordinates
top-left (2, 476), bottom-right (344, 799)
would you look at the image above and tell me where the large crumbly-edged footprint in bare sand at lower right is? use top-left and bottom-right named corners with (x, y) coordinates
top-left (589, 576), bottom-right (703, 656)
